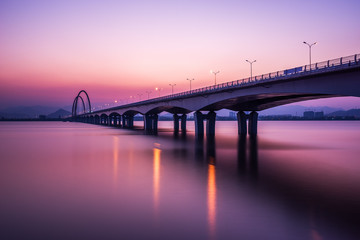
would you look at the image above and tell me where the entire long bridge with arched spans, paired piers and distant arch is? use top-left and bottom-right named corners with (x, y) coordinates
top-left (73, 54), bottom-right (360, 136)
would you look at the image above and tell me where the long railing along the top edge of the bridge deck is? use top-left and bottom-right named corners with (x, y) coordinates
top-left (88, 54), bottom-right (360, 112)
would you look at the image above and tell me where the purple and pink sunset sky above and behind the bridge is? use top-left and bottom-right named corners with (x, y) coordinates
top-left (0, 0), bottom-right (360, 109)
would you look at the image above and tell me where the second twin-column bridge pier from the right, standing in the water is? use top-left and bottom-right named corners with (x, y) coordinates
top-left (194, 111), bottom-right (216, 138)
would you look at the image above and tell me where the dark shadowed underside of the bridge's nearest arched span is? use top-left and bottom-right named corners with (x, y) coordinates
top-left (200, 93), bottom-right (339, 111)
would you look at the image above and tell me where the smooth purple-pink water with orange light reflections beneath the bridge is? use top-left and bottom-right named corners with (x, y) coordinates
top-left (0, 121), bottom-right (360, 240)
